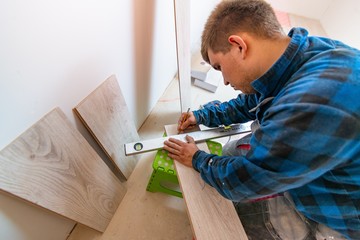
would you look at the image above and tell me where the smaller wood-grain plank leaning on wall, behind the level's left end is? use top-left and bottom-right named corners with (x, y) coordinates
top-left (74, 75), bottom-right (140, 179)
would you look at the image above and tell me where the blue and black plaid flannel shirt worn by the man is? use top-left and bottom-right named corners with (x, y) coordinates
top-left (193, 28), bottom-right (360, 239)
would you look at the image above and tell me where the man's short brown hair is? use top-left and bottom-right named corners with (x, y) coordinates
top-left (201, 0), bottom-right (283, 62)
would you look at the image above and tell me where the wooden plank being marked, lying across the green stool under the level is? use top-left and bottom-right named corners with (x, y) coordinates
top-left (165, 124), bottom-right (247, 240)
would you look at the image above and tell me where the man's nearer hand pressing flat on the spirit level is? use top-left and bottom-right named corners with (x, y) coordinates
top-left (164, 135), bottom-right (199, 167)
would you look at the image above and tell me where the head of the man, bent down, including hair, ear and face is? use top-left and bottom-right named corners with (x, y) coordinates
top-left (201, 0), bottom-right (288, 94)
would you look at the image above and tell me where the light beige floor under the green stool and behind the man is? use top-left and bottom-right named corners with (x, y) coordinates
top-left (68, 13), bottom-right (326, 240)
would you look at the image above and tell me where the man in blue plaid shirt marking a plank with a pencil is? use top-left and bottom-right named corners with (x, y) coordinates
top-left (164, 0), bottom-right (360, 239)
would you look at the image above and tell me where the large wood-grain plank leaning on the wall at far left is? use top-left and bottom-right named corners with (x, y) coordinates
top-left (0, 108), bottom-right (126, 231)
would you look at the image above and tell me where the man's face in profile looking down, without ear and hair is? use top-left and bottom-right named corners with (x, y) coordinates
top-left (208, 47), bottom-right (256, 94)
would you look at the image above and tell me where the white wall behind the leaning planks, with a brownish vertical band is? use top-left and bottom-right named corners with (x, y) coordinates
top-left (0, 0), bottom-right (220, 240)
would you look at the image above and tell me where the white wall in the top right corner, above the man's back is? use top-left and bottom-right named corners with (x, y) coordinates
top-left (320, 0), bottom-right (360, 49)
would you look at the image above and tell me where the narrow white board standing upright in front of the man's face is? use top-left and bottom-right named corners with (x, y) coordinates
top-left (174, 0), bottom-right (191, 112)
